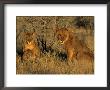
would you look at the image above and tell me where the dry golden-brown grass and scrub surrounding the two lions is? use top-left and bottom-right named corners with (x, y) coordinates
top-left (16, 17), bottom-right (94, 74)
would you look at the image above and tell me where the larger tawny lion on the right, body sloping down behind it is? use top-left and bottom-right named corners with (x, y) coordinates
top-left (55, 28), bottom-right (94, 62)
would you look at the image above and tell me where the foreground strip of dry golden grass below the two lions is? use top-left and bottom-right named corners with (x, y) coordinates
top-left (16, 53), bottom-right (94, 74)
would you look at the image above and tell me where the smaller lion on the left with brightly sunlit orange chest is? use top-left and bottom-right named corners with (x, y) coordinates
top-left (22, 32), bottom-right (40, 60)
